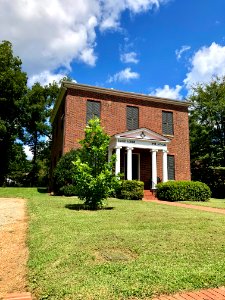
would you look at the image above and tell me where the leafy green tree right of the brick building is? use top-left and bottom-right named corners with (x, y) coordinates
top-left (189, 77), bottom-right (225, 166)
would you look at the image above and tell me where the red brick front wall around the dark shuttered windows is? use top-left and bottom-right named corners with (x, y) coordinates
top-left (53, 88), bottom-right (190, 181)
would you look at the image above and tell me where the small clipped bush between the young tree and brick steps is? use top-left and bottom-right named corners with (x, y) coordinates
top-left (116, 180), bottom-right (144, 200)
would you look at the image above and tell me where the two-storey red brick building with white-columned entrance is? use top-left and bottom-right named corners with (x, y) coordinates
top-left (51, 82), bottom-right (190, 189)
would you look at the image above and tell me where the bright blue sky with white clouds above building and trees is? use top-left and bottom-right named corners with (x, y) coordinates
top-left (0, 0), bottom-right (225, 99)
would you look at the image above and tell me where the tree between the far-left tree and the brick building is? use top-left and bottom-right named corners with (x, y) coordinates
top-left (23, 82), bottom-right (59, 186)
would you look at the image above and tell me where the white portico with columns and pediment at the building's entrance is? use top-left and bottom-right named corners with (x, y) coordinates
top-left (109, 128), bottom-right (170, 189)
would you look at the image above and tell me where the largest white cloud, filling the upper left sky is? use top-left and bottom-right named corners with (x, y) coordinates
top-left (0, 0), bottom-right (168, 76)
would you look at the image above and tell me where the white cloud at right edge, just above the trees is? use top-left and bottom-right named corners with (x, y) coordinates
top-left (184, 43), bottom-right (225, 89)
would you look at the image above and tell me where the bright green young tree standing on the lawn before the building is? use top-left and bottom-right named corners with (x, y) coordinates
top-left (74, 118), bottom-right (117, 210)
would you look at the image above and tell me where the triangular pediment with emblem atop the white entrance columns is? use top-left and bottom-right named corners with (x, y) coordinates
top-left (114, 128), bottom-right (170, 143)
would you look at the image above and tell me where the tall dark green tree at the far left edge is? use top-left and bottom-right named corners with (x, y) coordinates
top-left (0, 41), bottom-right (27, 186)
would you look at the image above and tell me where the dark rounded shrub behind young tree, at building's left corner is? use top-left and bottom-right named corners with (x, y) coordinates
top-left (53, 149), bottom-right (79, 196)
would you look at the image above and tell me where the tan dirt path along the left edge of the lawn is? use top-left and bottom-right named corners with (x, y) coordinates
top-left (0, 198), bottom-right (28, 299)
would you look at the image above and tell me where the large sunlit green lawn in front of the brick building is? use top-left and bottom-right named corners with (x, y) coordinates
top-left (0, 188), bottom-right (225, 300)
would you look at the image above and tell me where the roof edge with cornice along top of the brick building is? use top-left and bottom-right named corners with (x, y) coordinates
top-left (50, 81), bottom-right (190, 123)
